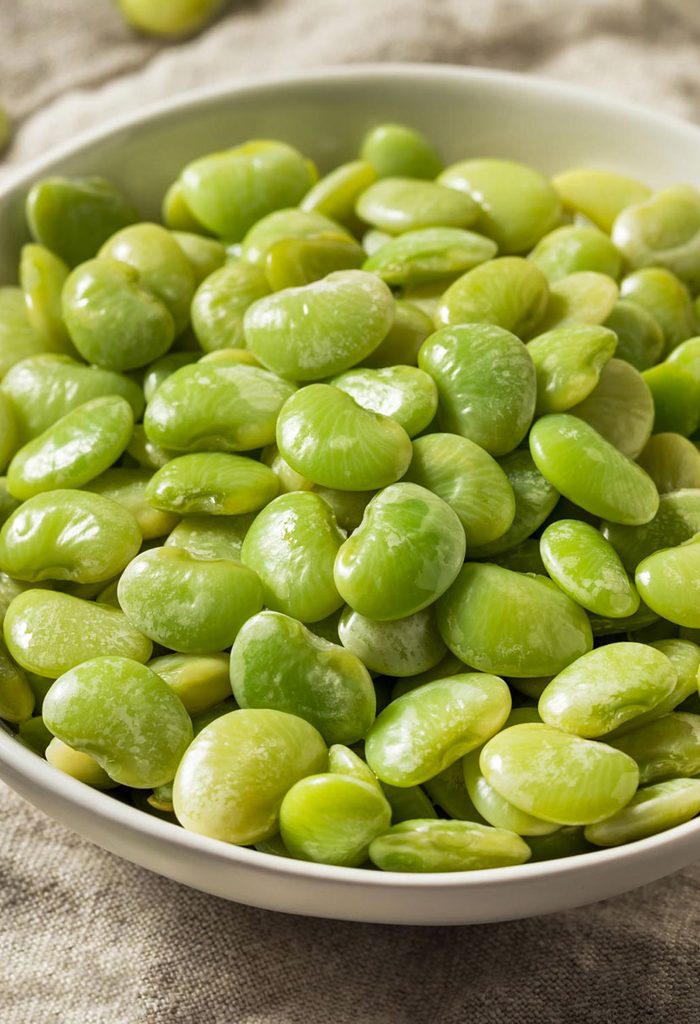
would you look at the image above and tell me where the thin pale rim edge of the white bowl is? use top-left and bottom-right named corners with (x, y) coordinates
top-left (0, 62), bottom-right (700, 892)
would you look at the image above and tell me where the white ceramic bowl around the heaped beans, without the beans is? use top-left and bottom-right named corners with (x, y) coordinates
top-left (0, 65), bottom-right (700, 925)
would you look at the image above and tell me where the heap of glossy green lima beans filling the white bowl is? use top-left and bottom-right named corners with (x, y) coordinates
top-left (0, 66), bottom-right (700, 929)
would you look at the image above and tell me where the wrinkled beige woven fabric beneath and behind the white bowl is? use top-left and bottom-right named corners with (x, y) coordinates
top-left (0, 0), bottom-right (700, 1024)
